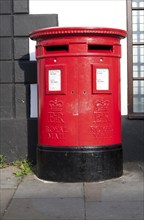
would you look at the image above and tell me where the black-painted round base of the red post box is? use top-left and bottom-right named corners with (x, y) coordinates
top-left (37, 145), bottom-right (123, 182)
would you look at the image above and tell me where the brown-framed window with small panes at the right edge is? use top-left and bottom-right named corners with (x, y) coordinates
top-left (127, 0), bottom-right (144, 118)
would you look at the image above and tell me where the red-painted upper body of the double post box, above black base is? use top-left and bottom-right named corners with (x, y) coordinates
top-left (30, 27), bottom-right (126, 147)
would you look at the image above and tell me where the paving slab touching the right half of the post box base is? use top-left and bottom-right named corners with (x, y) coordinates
top-left (84, 163), bottom-right (144, 202)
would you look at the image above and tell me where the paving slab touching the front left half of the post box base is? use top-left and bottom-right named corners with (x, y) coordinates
top-left (14, 175), bottom-right (83, 199)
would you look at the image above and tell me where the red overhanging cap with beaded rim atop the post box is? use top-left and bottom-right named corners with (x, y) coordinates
top-left (30, 27), bottom-right (126, 41)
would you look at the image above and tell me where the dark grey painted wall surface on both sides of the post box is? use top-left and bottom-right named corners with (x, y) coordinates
top-left (0, 0), bottom-right (144, 162)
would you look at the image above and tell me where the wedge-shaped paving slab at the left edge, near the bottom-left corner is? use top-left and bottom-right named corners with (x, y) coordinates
top-left (0, 189), bottom-right (15, 218)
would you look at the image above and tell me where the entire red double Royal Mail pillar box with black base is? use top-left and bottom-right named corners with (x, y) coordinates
top-left (30, 27), bottom-right (126, 182)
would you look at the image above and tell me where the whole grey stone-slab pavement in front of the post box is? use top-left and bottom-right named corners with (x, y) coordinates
top-left (0, 162), bottom-right (144, 220)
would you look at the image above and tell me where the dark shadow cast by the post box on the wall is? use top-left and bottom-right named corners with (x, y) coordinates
top-left (18, 54), bottom-right (38, 164)
